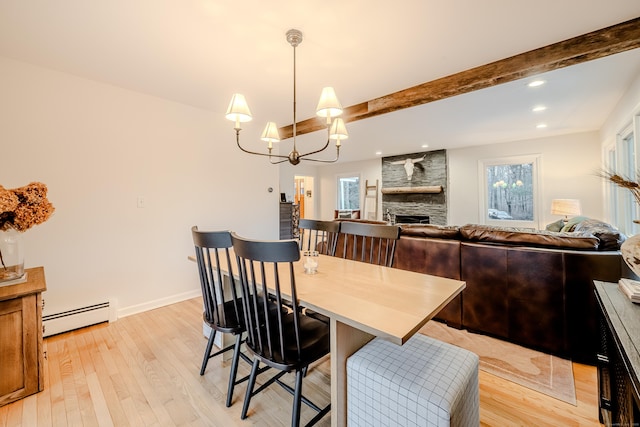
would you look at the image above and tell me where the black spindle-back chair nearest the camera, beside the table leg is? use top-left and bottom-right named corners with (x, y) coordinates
top-left (231, 233), bottom-right (331, 426)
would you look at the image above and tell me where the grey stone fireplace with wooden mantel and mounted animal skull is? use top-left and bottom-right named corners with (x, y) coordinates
top-left (382, 150), bottom-right (447, 225)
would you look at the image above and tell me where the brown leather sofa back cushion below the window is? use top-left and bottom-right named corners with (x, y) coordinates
top-left (460, 224), bottom-right (600, 250)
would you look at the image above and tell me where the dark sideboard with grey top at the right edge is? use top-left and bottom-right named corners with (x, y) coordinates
top-left (594, 281), bottom-right (640, 426)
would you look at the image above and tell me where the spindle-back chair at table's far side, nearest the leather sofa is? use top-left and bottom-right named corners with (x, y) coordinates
top-left (336, 221), bottom-right (400, 267)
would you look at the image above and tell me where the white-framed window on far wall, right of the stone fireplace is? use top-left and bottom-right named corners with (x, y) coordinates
top-left (479, 156), bottom-right (539, 229)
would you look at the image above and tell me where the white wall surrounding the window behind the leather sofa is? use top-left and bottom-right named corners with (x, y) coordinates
top-left (447, 132), bottom-right (604, 228)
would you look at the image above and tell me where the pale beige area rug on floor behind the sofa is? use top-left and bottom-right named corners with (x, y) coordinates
top-left (420, 320), bottom-right (576, 405)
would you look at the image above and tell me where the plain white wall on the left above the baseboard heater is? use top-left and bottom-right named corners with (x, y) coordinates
top-left (0, 57), bottom-right (279, 315)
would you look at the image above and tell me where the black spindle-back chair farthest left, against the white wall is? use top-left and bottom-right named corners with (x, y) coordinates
top-left (191, 226), bottom-right (264, 406)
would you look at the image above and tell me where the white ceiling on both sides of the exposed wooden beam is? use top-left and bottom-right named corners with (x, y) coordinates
top-left (0, 0), bottom-right (640, 161)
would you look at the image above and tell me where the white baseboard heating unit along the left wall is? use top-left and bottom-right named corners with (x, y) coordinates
top-left (42, 301), bottom-right (115, 337)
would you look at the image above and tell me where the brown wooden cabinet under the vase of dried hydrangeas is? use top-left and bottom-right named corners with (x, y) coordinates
top-left (0, 267), bottom-right (47, 406)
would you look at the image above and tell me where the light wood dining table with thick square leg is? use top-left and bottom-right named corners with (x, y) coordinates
top-left (190, 251), bottom-right (465, 426)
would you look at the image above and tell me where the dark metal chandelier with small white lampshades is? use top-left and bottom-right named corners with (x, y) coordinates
top-left (225, 29), bottom-right (349, 165)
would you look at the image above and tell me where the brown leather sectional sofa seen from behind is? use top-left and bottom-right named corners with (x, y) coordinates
top-left (394, 222), bottom-right (635, 364)
